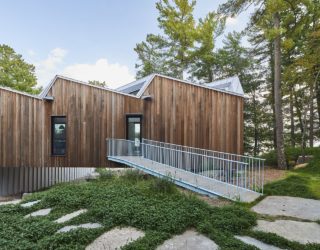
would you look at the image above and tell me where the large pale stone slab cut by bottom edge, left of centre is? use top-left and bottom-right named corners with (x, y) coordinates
top-left (86, 227), bottom-right (145, 250)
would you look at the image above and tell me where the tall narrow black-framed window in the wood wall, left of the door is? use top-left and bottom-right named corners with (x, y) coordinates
top-left (51, 116), bottom-right (66, 155)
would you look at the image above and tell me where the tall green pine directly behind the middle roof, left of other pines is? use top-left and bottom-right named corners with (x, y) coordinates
top-left (135, 0), bottom-right (197, 79)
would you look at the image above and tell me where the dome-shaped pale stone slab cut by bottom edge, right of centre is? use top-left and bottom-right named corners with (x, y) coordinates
top-left (157, 230), bottom-right (218, 250)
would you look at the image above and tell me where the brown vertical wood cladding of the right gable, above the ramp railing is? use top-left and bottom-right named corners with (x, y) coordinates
top-left (143, 76), bottom-right (243, 154)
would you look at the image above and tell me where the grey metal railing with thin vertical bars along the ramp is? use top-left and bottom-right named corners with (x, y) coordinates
top-left (108, 139), bottom-right (264, 193)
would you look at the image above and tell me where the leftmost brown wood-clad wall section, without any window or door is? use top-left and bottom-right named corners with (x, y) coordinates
top-left (0, 89), bottom-right (46, 167)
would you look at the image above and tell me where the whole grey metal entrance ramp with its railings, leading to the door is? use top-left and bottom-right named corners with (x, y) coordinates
top-left (107, 139), bottom-right (264, 202)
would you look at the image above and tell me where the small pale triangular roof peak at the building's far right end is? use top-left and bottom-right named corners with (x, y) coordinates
top-left (205, 76), bottom-right (244, 96)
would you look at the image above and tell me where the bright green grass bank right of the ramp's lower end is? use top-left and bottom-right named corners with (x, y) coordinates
top-left (264, 155), bottom-right (320, 200)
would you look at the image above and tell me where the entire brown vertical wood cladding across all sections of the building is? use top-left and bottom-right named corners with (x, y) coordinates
top-left (0, 76), bottom-right (243, 167)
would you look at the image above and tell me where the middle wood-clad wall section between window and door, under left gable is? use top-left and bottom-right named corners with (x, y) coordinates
top-left (45, 79), bottom-right (142, 167)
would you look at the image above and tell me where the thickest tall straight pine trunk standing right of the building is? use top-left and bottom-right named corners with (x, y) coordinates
top-left (273, 12), bottom-right (287, 169)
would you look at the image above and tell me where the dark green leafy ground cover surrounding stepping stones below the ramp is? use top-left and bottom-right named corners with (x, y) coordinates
top-left (0, 171), bottom-right (256, 250)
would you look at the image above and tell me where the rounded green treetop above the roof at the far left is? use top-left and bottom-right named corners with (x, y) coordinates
top-left (0, 44), bottom-right (41, 94)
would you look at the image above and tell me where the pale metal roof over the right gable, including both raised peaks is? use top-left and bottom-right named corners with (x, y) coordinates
top-left (117, 74), bottom-right (244, 98)
